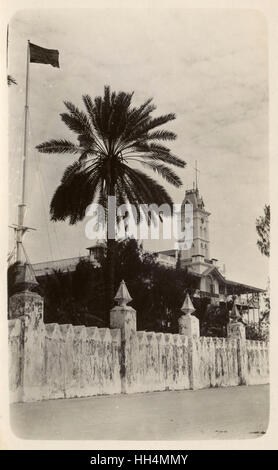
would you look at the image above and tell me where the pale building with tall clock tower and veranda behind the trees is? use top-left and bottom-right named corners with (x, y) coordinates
top-left (155, 188), bottom-right (264, 323)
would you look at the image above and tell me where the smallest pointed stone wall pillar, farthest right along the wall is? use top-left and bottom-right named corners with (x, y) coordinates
top-left (227, 302), bottom-right (247, 385)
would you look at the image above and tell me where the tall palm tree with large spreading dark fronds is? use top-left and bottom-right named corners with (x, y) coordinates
top-left (37, 86), bottom-right (185, 320)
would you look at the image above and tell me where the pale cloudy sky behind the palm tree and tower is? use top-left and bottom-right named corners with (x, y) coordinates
top-left (8, 9), bottom-right (269, 288)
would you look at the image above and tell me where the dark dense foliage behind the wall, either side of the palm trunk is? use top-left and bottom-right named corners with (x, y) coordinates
top-left (17, 239), bottom-right (199, 332)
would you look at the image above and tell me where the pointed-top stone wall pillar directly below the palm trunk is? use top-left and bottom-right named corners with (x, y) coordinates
top-left (110, 281), bottom-right (138, 393)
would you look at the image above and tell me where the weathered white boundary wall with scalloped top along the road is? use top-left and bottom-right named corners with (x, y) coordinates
top-left (8, 292), bottom-right (269, 402)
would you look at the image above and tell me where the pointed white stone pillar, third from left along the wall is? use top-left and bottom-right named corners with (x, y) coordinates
top-left (179, 294), bottom-right (200, 390)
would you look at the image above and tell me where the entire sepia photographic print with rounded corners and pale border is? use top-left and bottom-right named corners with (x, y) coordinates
top-left (2, 2), bottom-right (277, 452)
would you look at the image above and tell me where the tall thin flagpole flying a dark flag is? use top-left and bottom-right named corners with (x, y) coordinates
top-left (16, 40), bottom-right (30, 262)
